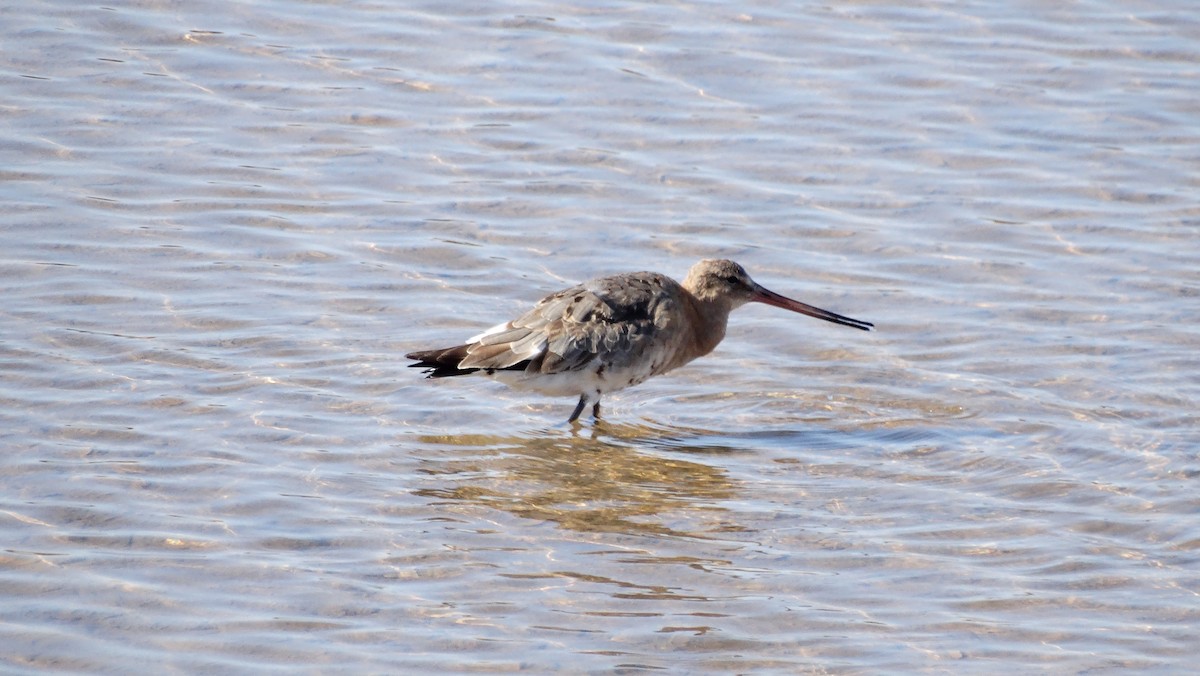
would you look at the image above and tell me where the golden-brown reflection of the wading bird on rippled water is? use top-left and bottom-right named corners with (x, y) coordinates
top-left (415, 423), bottom-right (740, 537)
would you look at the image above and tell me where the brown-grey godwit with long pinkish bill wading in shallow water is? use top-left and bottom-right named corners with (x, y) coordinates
top-left (404, 259), bottom-right (875, 423)
